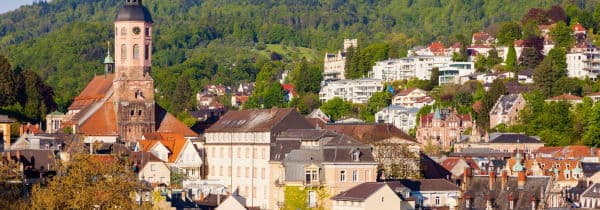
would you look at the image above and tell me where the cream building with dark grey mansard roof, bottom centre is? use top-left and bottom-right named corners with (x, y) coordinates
top-left (270, 129), bottom-right (378, 209)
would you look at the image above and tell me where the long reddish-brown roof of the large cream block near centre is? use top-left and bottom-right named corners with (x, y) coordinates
top-left (206, 108), bottom-right (312, 133)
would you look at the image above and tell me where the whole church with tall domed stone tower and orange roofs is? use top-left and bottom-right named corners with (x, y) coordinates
top-left (62, 0), bottom-right (199, 143)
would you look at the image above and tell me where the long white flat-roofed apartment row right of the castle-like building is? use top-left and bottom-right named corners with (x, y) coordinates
top-left (370, 56), bottom-right (452, 82)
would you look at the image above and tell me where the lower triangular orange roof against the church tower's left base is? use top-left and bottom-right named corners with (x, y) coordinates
top-left (78, 102), bottom-right (119, 136)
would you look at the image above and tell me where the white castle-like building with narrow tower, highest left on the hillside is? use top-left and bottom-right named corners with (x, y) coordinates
top-left (323, 39), bottom-right (358, 80)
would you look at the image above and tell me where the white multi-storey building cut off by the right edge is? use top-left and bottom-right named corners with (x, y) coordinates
top-left (567, 45), bottom-right (600, 80)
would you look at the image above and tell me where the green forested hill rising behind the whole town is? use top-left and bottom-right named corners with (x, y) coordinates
top-left (0, 0), bottom-right (598, 108)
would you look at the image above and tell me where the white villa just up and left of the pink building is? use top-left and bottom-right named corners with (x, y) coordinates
top-left (375, 105), bottom-right (420, 133)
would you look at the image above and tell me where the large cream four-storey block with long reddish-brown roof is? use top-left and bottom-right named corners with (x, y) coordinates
top-left (204, 108), bottom-right (312, 209)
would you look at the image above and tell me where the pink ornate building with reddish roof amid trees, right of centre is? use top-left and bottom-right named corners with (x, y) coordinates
top-left (417, 109), bottom-right (473, 150)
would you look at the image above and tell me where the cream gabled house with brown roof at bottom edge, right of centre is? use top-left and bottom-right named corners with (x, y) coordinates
top-left (331, 182), bottom-right (410, 210)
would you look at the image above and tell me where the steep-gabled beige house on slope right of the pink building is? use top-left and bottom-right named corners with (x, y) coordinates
top-left (490, 94), bottom-right (526, 128)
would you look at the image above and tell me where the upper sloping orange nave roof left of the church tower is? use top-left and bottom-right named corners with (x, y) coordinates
top-left (69, 74), bottom-right (114, 110)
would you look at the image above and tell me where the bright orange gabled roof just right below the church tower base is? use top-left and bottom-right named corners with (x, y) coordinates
top-left (138, 132), bottom-right (187, 163)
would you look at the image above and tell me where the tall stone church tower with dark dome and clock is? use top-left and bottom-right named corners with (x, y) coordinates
top-left (113, 0), bottom-right (156, 142)
